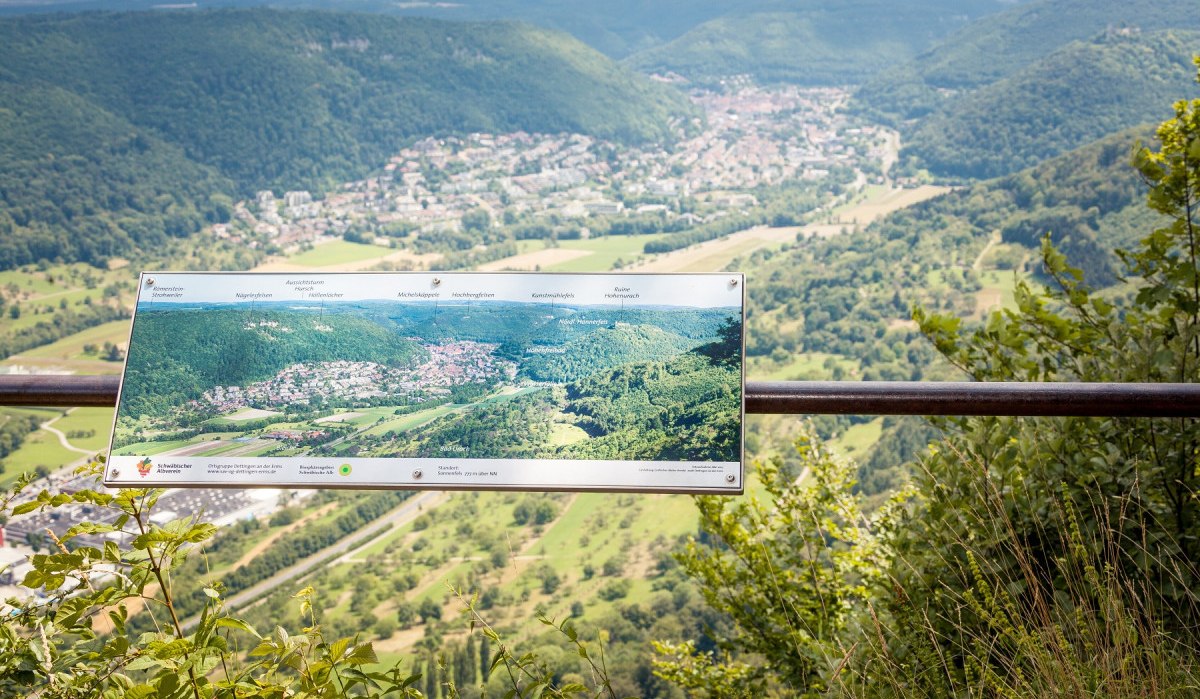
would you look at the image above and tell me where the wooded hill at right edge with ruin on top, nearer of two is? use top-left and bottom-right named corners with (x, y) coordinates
top-left (904, 31), bottom-right (1200, 178)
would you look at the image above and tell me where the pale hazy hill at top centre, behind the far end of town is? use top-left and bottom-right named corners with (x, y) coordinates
top-left (628, 0), bottom-right (1006, 84)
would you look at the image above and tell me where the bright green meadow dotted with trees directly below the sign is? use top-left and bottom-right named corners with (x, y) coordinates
top-left (250, 492), bottom-right (695, 663)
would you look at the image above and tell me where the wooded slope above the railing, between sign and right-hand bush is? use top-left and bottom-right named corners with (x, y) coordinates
top-left (746, 129), bottom-right (1156, 355)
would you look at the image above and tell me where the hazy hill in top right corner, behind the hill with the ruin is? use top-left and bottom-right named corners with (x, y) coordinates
top-left (857, 0), bottom-right (1200, 123)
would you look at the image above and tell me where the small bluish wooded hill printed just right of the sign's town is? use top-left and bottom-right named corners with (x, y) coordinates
top-left (521, 324), bottom-right (695, 383)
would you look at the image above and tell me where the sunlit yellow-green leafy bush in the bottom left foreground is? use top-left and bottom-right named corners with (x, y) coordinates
top-left (0, 462), bottom-right (420, 699)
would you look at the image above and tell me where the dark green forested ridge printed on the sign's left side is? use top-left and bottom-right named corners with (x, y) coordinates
top-left (121, 309), bottom-right (421, 417)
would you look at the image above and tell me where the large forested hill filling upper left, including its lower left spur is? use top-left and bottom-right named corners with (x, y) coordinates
top-left (0, 10), bottom-right (692, 268)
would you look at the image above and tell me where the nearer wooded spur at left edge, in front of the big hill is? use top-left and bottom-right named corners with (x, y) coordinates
top-left (0, 81), bottom-right (233, 269)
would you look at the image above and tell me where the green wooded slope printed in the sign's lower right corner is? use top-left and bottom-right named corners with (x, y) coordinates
top-left (388, 352), bottom-right (742, 461)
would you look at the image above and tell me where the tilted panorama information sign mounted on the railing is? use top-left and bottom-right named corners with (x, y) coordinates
top-left (104, 273), bottom-right (745, 494)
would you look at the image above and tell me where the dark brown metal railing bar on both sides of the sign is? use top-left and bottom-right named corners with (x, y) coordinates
top-left (0, 375), bottom-right (1200, 418)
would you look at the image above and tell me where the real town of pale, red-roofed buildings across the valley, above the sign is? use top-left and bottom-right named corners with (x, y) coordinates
top-left (223, 85), bottom-right (887, 253)
